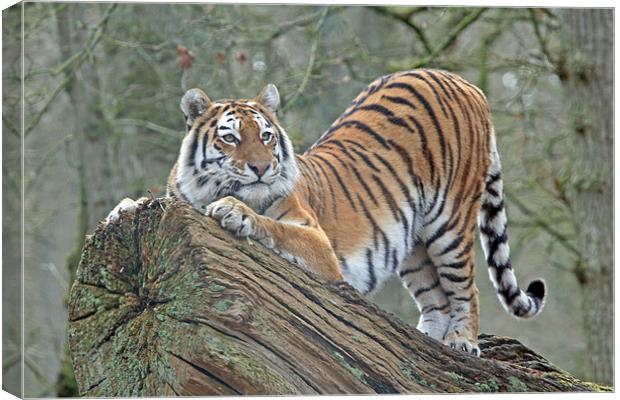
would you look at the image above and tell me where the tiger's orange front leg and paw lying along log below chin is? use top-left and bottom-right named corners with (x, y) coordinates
top-left (206, 196), bottom-right (344, 282)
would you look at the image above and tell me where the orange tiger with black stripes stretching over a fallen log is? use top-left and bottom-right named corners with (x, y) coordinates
top-left (111, 69), bottom-right (546, 356)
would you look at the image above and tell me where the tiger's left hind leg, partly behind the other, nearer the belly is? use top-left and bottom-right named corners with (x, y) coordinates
top-left (398, 245), bottom-right (450, 341)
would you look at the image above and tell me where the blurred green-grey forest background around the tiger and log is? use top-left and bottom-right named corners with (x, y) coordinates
top-left (2, 2), bottom-right (613, 397)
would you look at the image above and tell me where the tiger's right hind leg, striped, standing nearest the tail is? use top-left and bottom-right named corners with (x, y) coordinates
top-left (426, 225), bottom-right (480, 356)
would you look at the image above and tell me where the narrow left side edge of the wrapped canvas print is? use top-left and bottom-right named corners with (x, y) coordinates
top-left (2, 4), bottom-right (24, 397)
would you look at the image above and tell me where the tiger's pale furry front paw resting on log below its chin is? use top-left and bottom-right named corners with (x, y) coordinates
top-left (206, 196), bottom-right (256, 237)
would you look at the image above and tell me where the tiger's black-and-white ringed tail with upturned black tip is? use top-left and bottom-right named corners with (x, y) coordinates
top-left (478, 130), bottom-right (546, 318)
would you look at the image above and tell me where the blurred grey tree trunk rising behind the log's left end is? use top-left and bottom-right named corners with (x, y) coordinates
top-left (54, 4), bottom-right (114, 397)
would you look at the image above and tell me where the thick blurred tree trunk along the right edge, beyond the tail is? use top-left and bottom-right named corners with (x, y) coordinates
top-left (563, 9), bottom-right (614, 384)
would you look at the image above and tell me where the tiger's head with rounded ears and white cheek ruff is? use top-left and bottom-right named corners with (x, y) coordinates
top-left (175, 84), bottom-right (298, 210)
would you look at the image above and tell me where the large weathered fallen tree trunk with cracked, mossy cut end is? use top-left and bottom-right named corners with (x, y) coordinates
top-left (69, 199), bottom-right (608, 397)
